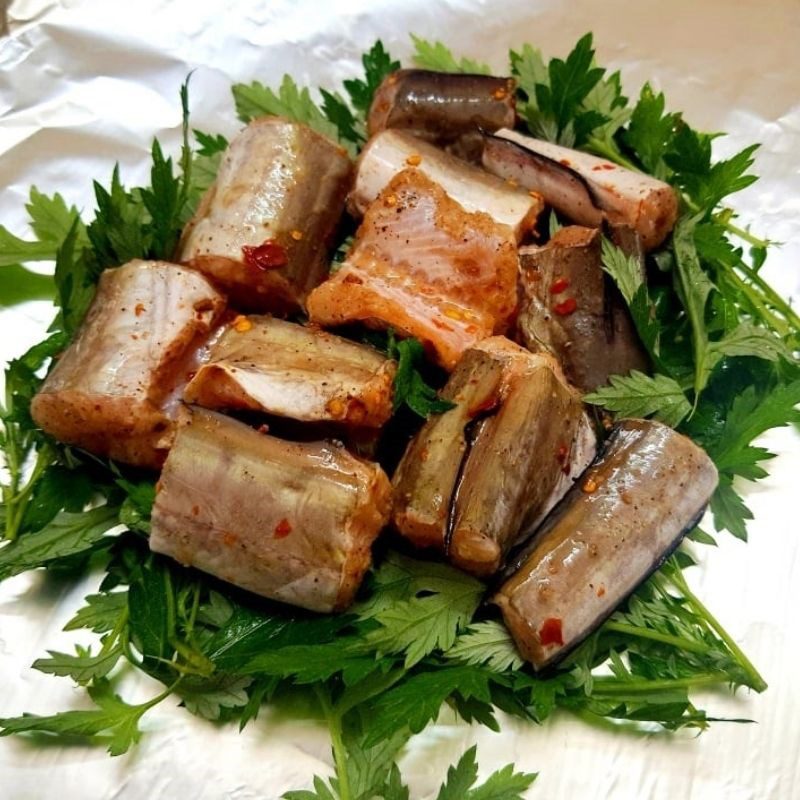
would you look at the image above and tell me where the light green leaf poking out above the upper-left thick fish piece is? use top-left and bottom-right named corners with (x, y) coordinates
top-left (232, 75), bottom-right (346, 152)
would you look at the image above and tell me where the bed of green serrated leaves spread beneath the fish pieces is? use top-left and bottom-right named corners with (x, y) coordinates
top-left (0, 34), bottom-right (800, 800)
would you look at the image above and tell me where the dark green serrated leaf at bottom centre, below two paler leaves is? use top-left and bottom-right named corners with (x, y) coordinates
top-left (365, 666), bottom-right (491, 747)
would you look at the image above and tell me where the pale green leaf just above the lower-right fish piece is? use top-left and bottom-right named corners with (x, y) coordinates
top-left (583, 370), bottom-right (692, 428)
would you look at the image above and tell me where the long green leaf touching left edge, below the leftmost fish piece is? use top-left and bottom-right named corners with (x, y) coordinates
top-left (0, 505), bottom-right (118, 580)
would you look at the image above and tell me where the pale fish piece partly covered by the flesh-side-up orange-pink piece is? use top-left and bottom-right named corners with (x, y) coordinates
top-left (347, 130), bottom-right (544, 242)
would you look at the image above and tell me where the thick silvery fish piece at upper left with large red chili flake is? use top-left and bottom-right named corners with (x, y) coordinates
top-left (179, 117), bottom-right (352, 314)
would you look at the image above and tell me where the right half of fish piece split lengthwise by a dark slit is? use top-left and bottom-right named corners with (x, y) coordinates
top-left (448, 337), bottom-right (595, 576)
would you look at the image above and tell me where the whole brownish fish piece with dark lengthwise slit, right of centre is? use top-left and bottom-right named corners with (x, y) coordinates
top-left (392, 337), bottom-right (594, 576)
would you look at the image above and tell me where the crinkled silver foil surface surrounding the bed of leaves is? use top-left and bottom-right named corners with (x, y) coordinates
top-left (0, 0), bottom-right (800, 800)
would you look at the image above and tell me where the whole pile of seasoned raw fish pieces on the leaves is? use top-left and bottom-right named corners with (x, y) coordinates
top-left (32, 70), bottom-right (717, 669)
